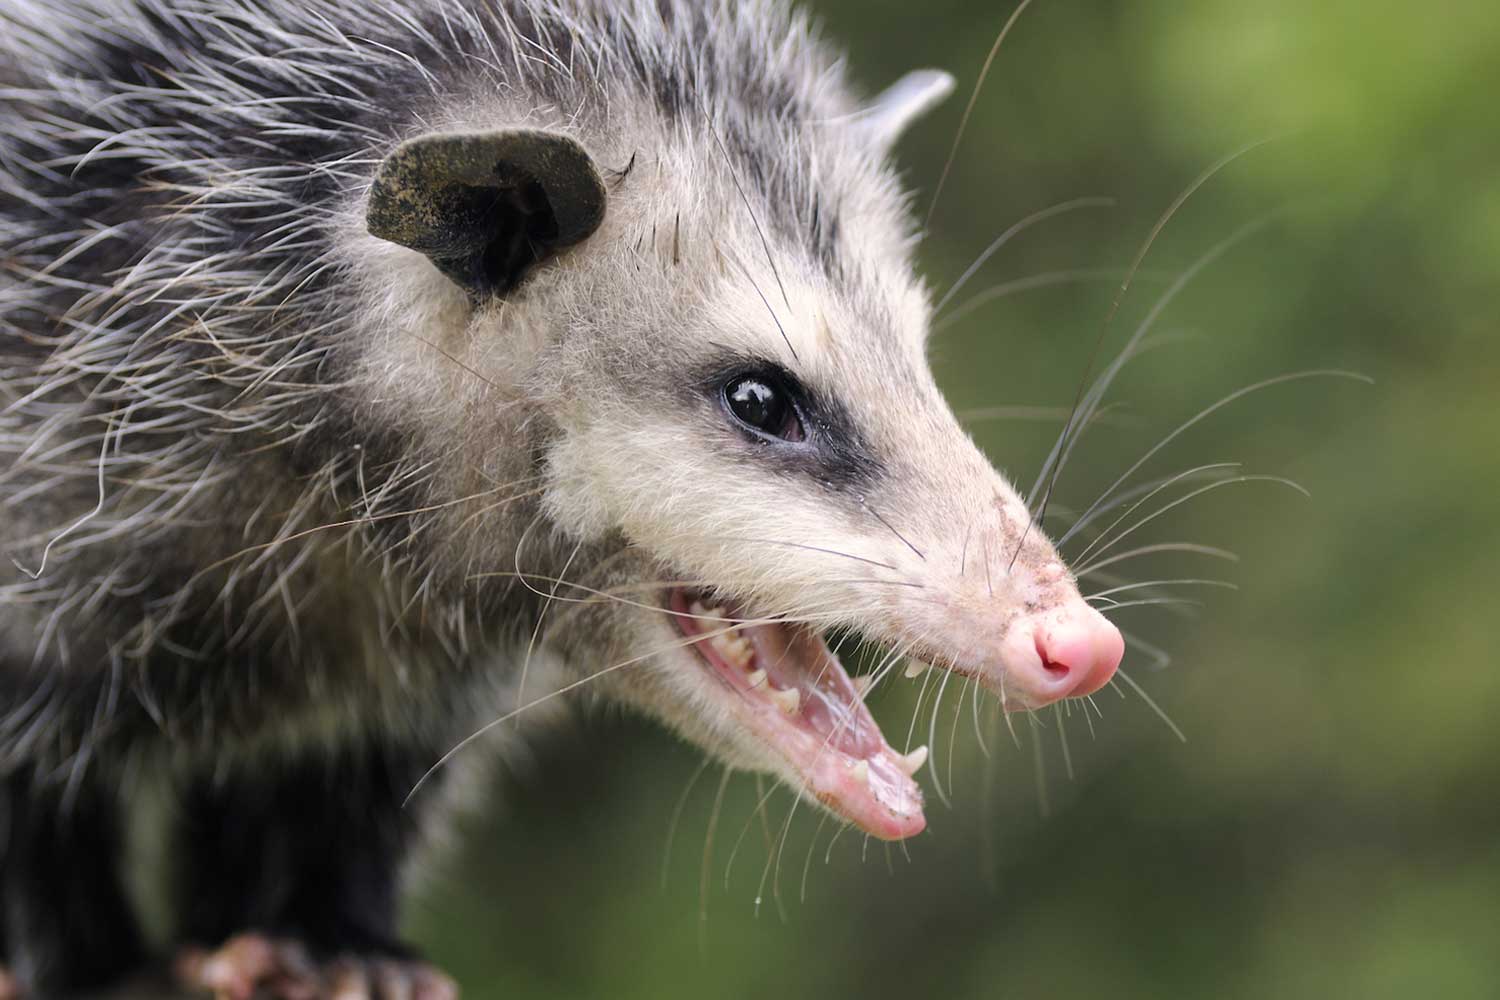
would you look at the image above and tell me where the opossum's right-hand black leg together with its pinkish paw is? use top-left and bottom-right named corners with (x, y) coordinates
top-left (176, 745), bottom-right (455, 1000)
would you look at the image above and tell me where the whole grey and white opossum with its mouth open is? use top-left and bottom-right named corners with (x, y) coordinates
top-left (0, 0), bottom-right (1124, 997)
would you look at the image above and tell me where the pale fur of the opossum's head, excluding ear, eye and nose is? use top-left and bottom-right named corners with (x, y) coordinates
top-left (331, 6), bottom-right (1118, 835)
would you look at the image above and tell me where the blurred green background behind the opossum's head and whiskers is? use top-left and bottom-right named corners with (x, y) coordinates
top-left (411, 0), bottom-right (1500, 1000)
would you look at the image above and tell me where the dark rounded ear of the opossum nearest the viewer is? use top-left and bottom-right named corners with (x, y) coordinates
top-left (365, 129), bottom-right (605, 298)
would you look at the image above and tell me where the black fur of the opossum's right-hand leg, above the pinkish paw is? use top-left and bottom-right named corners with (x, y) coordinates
top-left (177, 745), bottom-right (432, 958)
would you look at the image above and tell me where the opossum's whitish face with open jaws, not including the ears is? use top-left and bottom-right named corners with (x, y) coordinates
top-left (548, 258), bottom-right (1122, 838)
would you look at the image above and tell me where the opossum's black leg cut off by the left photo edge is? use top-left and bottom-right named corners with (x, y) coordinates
top-left (0, 772), bottom-right (146, 997)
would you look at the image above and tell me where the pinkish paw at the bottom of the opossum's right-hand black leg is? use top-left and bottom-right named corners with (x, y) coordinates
top-left (175, 934), bottom-right (459, 1000)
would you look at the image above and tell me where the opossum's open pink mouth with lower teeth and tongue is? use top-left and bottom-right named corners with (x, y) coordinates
top-left (666, 588), bottom-right (927, 840)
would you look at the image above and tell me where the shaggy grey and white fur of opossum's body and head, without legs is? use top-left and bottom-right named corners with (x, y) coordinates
top-left (0, 0), bottom-right (1092, 989)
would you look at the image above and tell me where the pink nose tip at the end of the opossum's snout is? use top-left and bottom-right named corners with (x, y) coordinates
top-left (1005, 598), bottom-right (1125, 708)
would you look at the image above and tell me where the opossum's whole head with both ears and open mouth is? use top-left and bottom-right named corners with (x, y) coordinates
top-left (368, 73), bottom-right (1122, 838)
